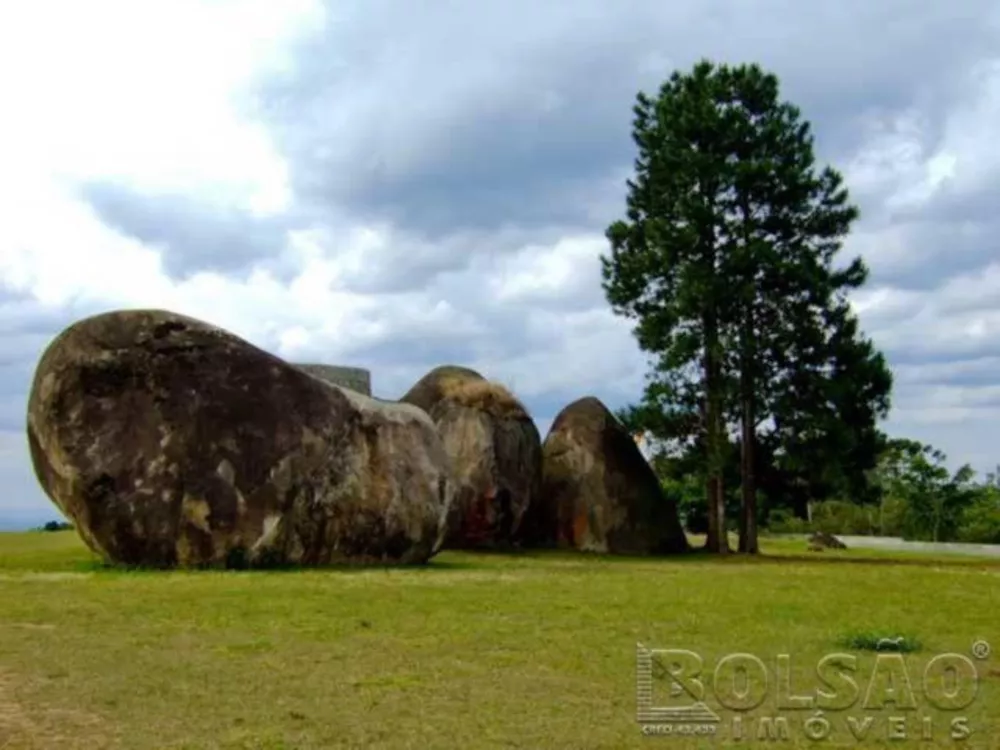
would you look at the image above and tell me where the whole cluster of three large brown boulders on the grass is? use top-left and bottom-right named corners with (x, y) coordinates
top-left (27, 310), bottom-right (686, 567)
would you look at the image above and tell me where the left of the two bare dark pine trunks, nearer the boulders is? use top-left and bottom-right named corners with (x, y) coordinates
top-left (705, 313), bottom-right (730, 554)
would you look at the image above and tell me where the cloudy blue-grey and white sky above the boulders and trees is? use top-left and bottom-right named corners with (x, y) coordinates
top-left (0, 0), bottom-right (1000, 526)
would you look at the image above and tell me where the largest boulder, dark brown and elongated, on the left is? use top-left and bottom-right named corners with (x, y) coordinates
top-left (27, 310), bottom-right (451, 567)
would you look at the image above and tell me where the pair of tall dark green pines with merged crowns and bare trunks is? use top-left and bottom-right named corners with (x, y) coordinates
top-left (602, 61), bottom-right (887, 552)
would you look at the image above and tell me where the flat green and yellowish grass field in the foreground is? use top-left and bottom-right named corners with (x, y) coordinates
top-left (0, 532), bottom-right (1000, 750)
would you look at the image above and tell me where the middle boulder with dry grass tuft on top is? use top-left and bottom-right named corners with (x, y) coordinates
top-left (401, 365), bottom-right (542, 549)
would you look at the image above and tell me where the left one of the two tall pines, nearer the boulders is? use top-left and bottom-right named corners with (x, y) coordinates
top-left (602, 63), bottom-right (731, 552)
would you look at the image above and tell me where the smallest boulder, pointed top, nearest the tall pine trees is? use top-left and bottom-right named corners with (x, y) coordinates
top-left (525, 397), bottom-right (688, 555)
